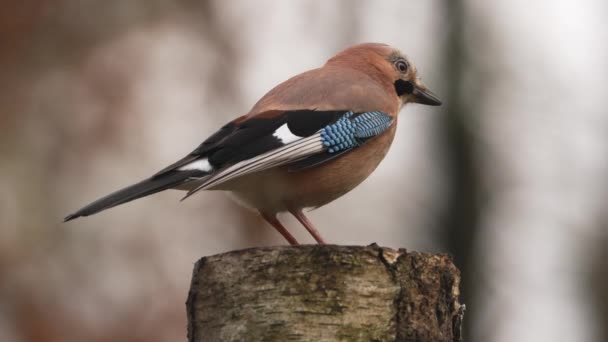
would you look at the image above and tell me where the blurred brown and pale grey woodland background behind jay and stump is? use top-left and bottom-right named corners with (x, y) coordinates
top-left (0, 0), bottom-right (608, 342)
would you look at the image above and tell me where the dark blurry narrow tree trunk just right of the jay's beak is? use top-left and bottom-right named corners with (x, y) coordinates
top-left (438, 0), bottom-right (481, 340)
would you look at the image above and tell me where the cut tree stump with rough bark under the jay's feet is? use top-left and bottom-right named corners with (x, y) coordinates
top-left (186, 245), bottom-right (464, 341)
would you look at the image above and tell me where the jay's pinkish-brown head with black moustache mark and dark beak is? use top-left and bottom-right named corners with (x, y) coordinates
top-left (328, 43), bottom-right (441, 106)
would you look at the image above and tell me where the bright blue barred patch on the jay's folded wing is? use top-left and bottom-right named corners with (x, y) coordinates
top-left (320, 112), bottom-right (393, 153)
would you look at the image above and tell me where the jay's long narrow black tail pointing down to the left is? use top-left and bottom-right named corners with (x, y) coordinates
top-left (63, 170), bottom-right (201, 222)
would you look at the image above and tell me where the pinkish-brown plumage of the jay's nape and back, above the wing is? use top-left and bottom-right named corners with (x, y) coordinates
top-left (247, 43), bottom-right (400, 117)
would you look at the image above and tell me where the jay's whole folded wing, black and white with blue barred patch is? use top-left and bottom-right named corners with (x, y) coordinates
top-left (164, 110), bottom-right (393, 198)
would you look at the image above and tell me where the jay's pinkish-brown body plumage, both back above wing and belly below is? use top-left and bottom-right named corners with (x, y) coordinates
top-left (218, 44), bottom-right (401, 214)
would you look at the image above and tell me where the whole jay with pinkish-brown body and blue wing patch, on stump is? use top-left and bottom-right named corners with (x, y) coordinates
top-left (64, 43), bottom-right (441, 245)
